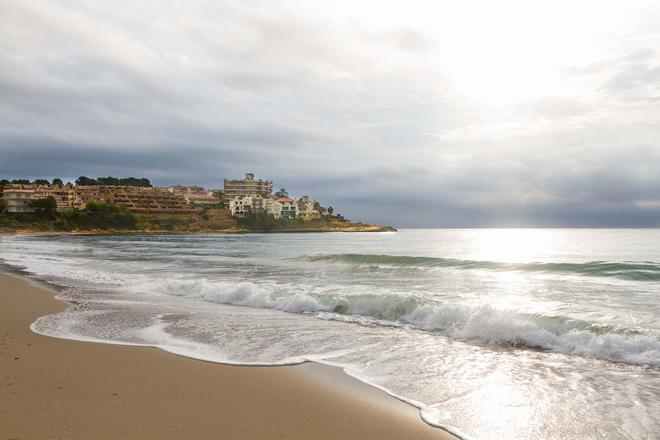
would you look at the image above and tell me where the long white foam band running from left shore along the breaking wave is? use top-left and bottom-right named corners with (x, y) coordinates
top-left (3, 246), bottom-right (660, 367)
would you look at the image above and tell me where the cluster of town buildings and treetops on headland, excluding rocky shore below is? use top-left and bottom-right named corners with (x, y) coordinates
top-left (0, 173), bottom-right (341, 221)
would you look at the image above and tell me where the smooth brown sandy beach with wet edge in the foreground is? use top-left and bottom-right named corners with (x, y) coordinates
top-left (0, 274), bottom-right (454, 439)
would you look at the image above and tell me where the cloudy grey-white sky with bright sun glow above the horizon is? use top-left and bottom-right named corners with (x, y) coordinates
top-left (0, 0), bottom-right (660, 227)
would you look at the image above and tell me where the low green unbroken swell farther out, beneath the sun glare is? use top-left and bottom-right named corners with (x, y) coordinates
top-left (305, 254), bottom-right (660, 281)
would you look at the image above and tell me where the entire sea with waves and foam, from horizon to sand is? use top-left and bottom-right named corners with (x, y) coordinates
top-left (0, 229), bottom-right (660, 440)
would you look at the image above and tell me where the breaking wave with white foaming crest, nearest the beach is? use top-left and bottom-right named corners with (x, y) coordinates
top-left (131, 278), bottom-right (660, 367)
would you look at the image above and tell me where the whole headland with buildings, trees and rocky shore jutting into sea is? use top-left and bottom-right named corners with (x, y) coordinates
top-left (0, 173), bottom-right (394, 232)
